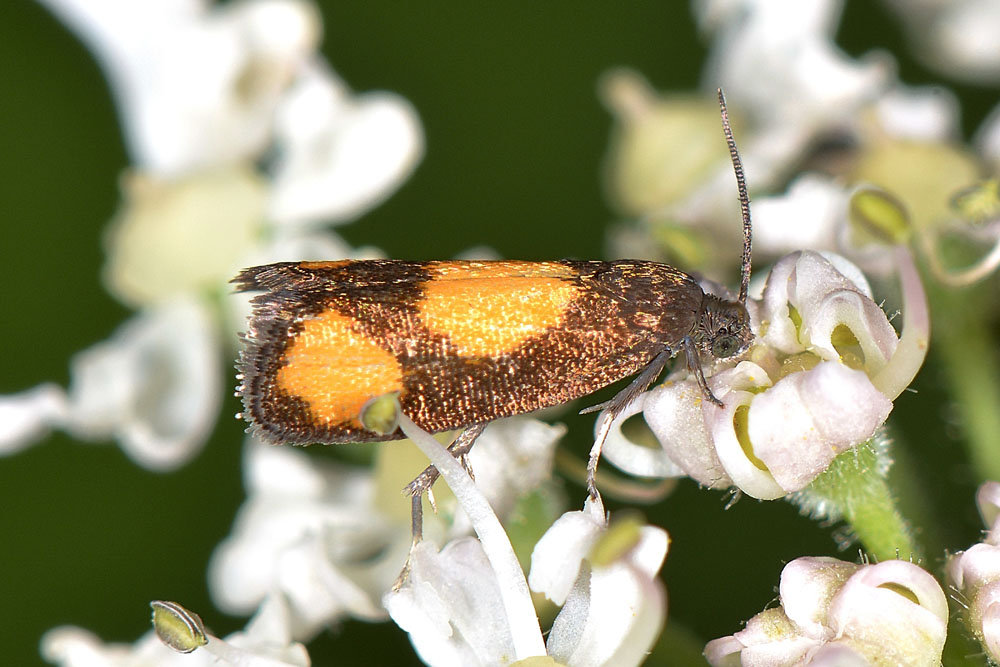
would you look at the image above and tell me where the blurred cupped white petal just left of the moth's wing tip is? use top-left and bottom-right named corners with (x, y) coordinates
top-left (66, 300), bottom-right (222, 470)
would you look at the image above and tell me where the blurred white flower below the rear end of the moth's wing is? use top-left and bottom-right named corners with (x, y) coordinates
top-left (209, 437), bottom-right (410, 640)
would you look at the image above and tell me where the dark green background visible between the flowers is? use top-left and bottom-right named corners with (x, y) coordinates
top-left (0, 0), bottom-right (995, 664)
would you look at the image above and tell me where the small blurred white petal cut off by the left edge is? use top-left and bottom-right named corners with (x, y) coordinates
top-left (0, 383), bottom-right (67, 455)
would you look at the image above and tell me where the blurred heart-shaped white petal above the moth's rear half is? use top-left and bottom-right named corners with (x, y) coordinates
top-left (271, 58), bottom-right (423, 223)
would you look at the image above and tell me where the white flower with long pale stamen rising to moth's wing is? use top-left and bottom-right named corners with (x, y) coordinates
top-left (384, 416), bottom-right (668, 666)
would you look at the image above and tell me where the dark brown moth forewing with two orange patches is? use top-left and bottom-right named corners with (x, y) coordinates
top-left (234, 260), bottom-right (701, 443)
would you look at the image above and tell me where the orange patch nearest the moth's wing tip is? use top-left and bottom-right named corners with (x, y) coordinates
top-left (275, 310), bottom-right (402, 428)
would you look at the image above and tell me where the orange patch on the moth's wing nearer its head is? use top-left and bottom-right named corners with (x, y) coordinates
top-left (416, 262), bottom-right (578, 357)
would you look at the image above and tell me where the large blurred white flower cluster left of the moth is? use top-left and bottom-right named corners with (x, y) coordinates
top-left (0, 0), bottom-right (423, 470)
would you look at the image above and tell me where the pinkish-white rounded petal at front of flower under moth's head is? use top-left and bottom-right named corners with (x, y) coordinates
top-left (752, 361), bottom-right (892, 495)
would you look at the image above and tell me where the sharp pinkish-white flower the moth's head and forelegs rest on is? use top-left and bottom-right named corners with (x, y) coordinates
top-left (605, 252), bottom-right (929, 499)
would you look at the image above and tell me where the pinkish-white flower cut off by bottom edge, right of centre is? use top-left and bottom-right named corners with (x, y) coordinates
top-left (705, 558), bottom-right (948, 667)
